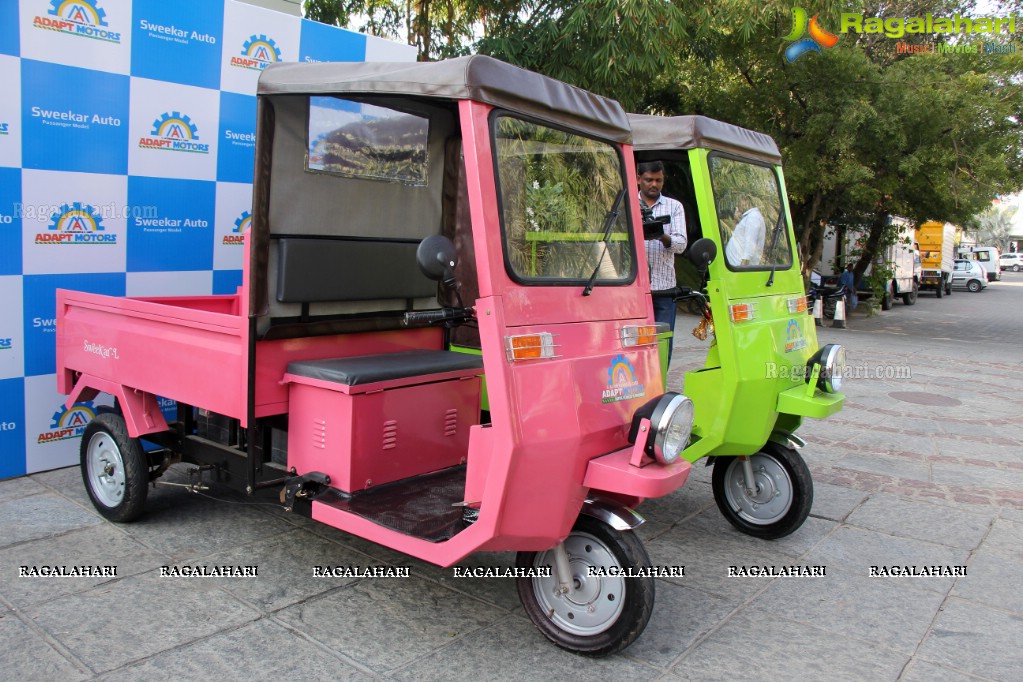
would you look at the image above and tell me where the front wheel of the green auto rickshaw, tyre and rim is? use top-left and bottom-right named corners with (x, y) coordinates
top-left (711, 443), bottom-right (813, 540)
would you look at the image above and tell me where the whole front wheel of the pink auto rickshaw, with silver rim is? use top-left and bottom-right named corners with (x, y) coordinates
top-left (516, 516), bottom-right (654, 656)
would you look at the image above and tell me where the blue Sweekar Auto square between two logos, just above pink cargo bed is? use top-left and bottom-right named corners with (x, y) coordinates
top-left (128, 177), bottom-right (217, 272)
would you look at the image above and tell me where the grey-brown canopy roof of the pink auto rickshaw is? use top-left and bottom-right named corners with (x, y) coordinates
top-left (257, 55), bottom-right (631, 143)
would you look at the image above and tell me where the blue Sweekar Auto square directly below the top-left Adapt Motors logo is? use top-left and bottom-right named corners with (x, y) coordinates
top-left (21, 59), bottom-right (129, 175)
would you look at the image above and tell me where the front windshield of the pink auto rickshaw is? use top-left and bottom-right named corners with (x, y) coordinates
top-left (493, 116), bottom-right (635, 285)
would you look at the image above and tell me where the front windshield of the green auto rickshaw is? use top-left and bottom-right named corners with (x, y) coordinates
top-left (708, 154), bottom-right (792, 270)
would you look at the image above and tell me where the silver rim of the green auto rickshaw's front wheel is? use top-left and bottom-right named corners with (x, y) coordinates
top-left (724, 454), bottom-right (793, 526)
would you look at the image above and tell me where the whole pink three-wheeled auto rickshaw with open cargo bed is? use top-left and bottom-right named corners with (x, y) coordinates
top-left (57, 56), bottom-right (694, 655)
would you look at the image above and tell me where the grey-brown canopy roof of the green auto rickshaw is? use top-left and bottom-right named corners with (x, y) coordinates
top-left (628, 113), bottom-right (782, 164)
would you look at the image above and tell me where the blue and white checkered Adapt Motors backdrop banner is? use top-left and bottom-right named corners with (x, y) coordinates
top-left (0, 0), bottom-right (415, 479)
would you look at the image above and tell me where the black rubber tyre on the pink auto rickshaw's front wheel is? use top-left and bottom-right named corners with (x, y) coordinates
top-left (516, 516), bottom-right (655, 656)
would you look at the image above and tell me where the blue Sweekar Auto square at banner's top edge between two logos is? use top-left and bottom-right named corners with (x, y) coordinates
top-left (131, 0), bottom-right (224, 89)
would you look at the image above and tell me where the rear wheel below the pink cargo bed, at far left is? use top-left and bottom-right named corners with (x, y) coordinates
top-left (80, 411), bottom-right (149, 524)
